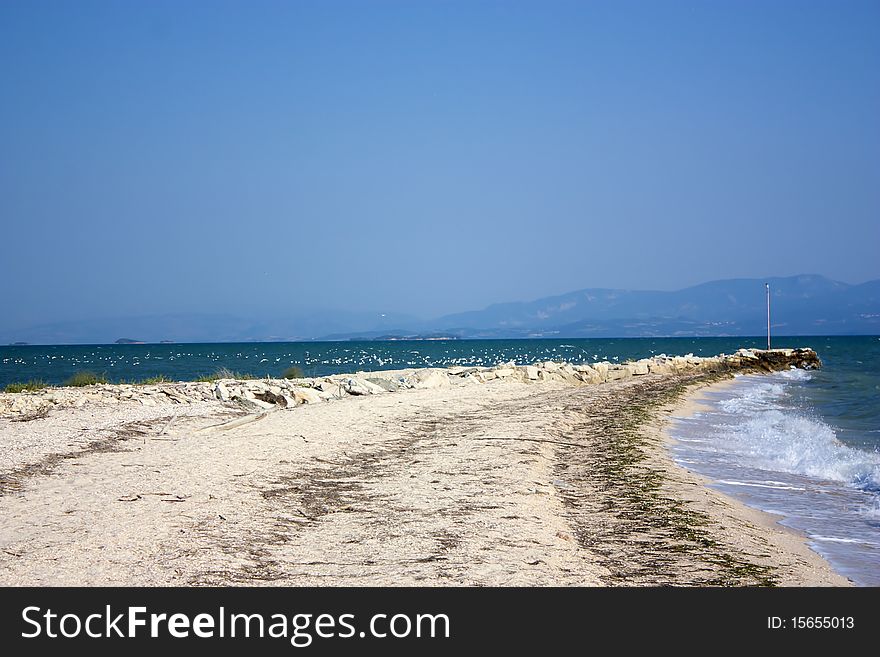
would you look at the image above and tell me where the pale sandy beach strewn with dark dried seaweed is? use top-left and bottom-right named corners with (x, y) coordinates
top-left (0, 356), bottom-right (848, 586)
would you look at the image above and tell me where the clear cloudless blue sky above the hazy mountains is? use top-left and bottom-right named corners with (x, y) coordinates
top-left (0, 0), bottom-right (880, 327)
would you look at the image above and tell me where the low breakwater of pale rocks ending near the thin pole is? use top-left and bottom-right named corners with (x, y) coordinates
top-left (0, 348), bottom-right (821, 420)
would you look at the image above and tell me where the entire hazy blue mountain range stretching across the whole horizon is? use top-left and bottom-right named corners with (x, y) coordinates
top-left (3, 275), bottom-right (880, 344)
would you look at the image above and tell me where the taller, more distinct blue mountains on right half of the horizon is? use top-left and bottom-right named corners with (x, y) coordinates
top-left (416, 275), bottom-right (880, 337)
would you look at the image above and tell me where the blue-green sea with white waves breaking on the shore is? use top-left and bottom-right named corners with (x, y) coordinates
top-left (0, 336), bottom-right (880, 586)
